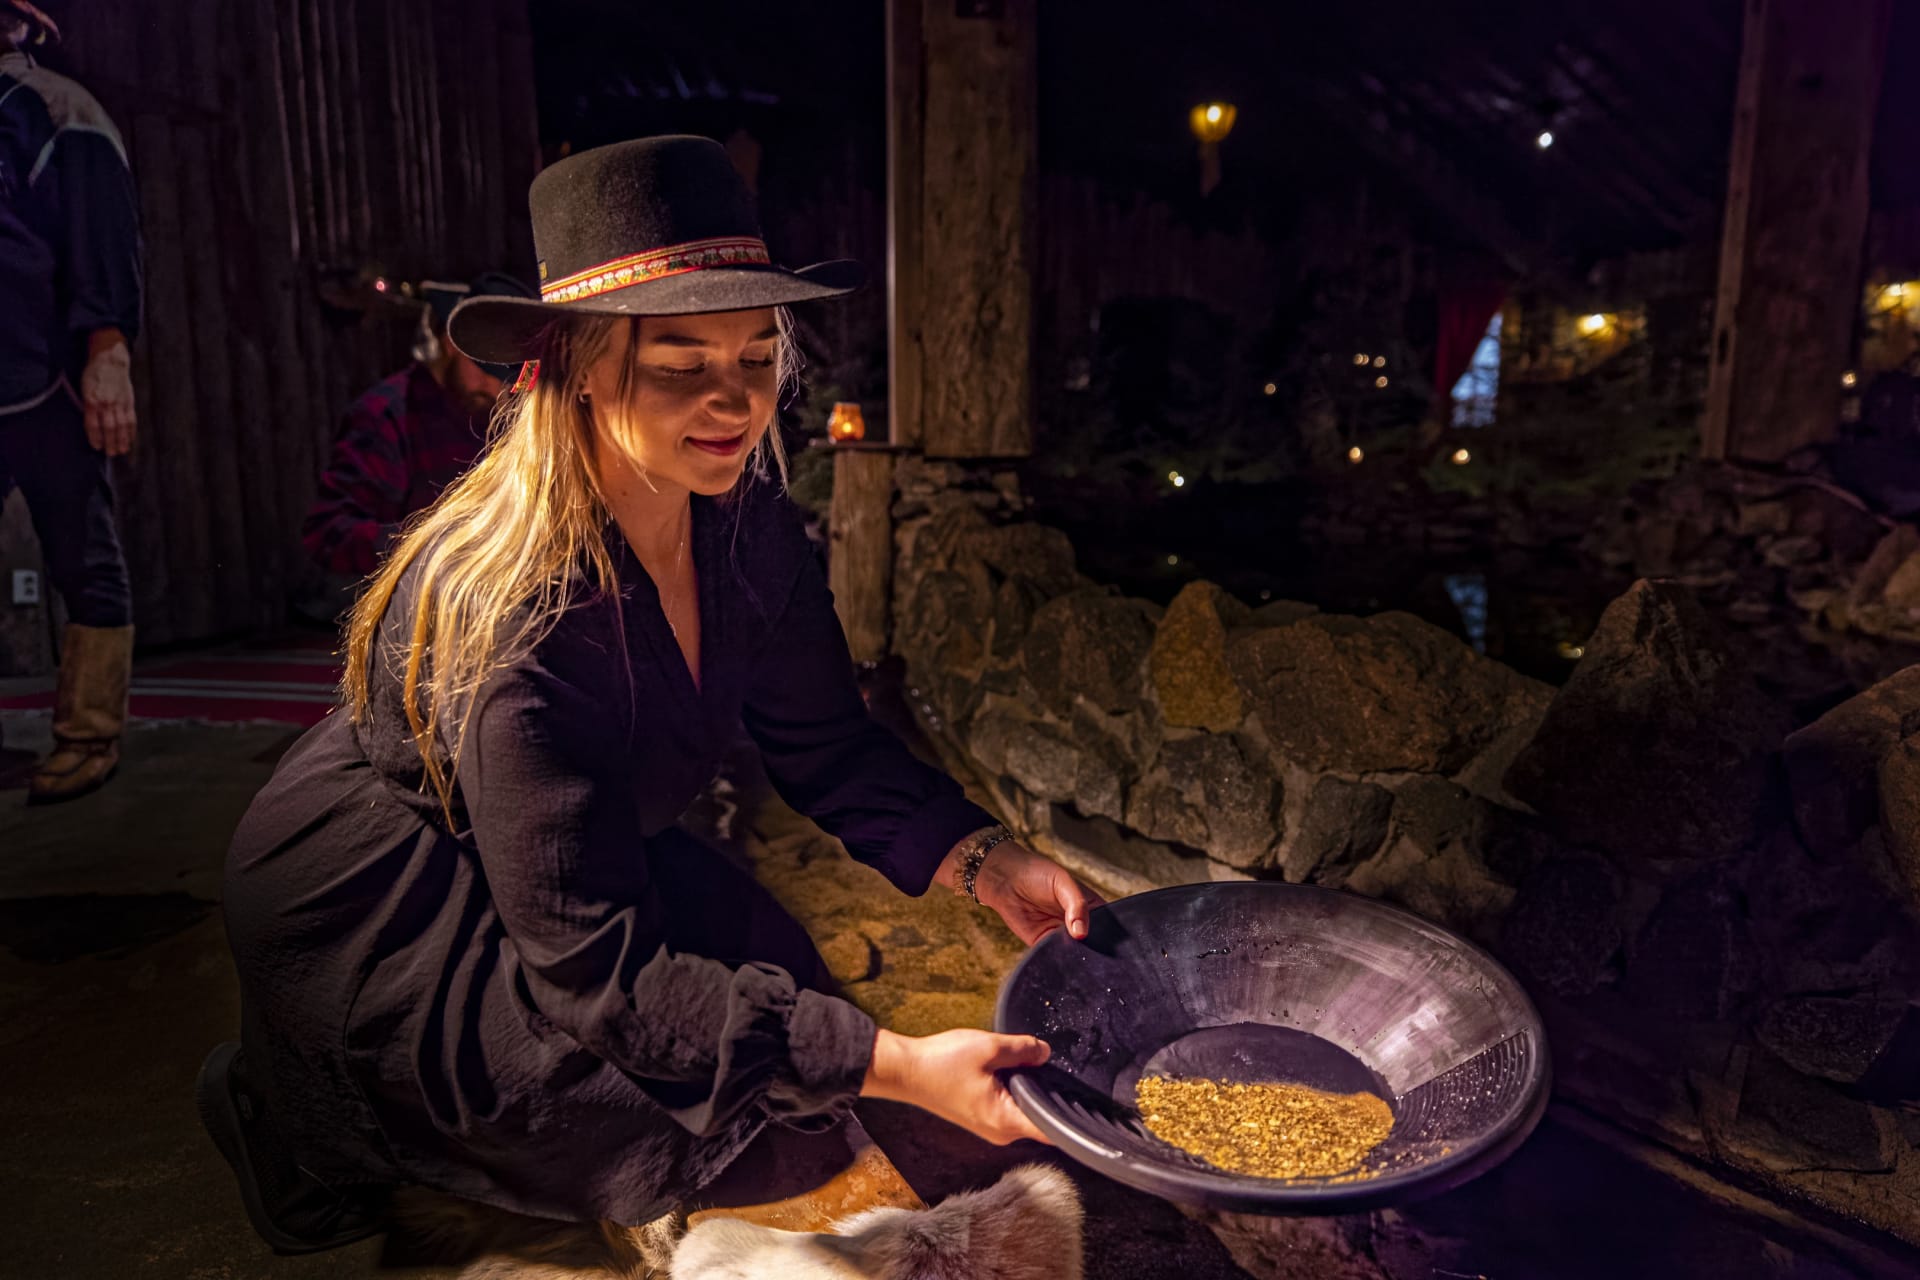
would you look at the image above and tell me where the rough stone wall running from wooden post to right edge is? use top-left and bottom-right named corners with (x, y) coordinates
top-left (895, 459), bottom-right (1920, 1240)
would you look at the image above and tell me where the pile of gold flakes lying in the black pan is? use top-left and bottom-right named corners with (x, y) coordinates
top-left (1135, 1075), bottom-right (1394, 1178)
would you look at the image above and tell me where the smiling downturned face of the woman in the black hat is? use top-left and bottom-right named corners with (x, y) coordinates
top-left (586, 309), bottom-right (780, 495)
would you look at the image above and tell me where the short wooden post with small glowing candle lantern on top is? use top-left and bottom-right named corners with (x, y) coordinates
top-left (828, 445), bottom-right (895, 662)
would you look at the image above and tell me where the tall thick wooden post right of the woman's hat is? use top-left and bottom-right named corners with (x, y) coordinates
top-left (889, 0), bottom-right (1039, 459)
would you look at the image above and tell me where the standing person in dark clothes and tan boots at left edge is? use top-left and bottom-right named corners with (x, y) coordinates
top-left (0, 0), bottom-right (140, 802)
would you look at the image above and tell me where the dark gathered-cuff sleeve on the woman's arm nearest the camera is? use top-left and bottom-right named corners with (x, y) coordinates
top-left (461, 660), bottom-right (876, 1136)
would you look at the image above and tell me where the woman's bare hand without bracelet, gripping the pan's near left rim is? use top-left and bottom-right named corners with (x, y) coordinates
top-left (860, 1031), bottom-right (1052, 1146)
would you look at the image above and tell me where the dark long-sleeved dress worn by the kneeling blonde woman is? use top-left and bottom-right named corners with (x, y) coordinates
top-left (227, 475), bottom-right (993, 1222)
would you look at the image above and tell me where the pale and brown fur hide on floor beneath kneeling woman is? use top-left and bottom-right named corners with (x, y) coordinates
top-left (396, 1165), bottom-right (1081, 1280)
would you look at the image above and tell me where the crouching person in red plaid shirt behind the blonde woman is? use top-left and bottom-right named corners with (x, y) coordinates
top-left (300, 271), bottom-right (534, 622)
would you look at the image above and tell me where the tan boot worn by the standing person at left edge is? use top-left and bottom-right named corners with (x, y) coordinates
top-left (27, 622), bottom-right (132, 804)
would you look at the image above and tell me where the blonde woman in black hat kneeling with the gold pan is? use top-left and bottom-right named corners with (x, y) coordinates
top-left (200, 138), bottom-right (1096, 1247)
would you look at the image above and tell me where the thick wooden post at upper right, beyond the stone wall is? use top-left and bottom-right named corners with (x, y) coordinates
top-left (1701, 0), bottom-right (1891, 462)
